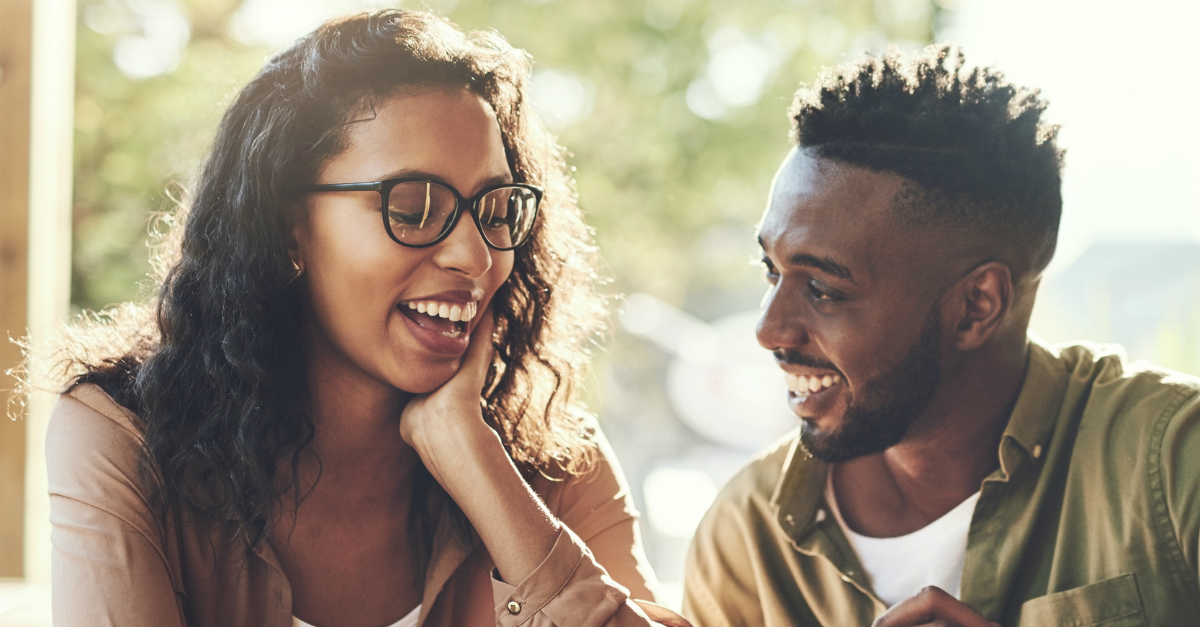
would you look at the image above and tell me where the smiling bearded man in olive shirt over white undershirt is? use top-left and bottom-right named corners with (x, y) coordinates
top-left (684, 47), bottom-right (1200, 627)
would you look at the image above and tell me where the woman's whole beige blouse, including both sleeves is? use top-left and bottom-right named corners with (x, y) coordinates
top-left (46, 384), bottom-right (686, 627)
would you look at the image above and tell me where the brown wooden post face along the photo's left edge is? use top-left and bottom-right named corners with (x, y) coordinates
top-left (0, 0), bottom-right (32, 577)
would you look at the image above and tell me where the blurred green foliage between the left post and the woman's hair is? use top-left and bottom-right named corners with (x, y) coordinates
top-left (71, 0), bottom-right (266, 309)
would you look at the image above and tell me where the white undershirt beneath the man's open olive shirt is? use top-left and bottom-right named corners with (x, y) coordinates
top-left (826, 471), bottom-right (979, 608)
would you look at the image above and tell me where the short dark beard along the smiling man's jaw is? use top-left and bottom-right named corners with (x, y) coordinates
top-left (800, 303), bottom-right (942, 464)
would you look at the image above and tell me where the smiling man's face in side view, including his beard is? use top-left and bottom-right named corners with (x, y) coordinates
top-left (757, 150), bottom-right (944, 462)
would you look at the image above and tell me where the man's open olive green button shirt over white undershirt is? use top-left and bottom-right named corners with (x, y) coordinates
top-left (684, 339), bottom-right (1200, 627)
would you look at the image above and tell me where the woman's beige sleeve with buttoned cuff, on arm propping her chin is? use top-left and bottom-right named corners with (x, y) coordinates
top-left (492, 430), bottom-right (688, 627)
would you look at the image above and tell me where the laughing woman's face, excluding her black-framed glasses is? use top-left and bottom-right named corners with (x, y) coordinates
top-left (293, 88), bottom-right (514, 394)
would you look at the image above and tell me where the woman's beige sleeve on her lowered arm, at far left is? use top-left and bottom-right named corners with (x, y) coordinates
top-left (46, 389), bottom-right (185, 627)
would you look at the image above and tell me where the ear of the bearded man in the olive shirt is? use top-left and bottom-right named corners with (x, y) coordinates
top-left (942, 262), bottom-right (1013, 351)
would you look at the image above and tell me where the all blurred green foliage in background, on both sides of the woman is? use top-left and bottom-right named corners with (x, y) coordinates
top-left (72, 0), bottom-right (930, 317)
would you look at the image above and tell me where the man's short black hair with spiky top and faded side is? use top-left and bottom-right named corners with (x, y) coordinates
top-left (788, 44), bottom-right (1062, 280)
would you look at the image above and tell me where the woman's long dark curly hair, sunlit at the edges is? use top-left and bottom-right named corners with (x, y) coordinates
top-left (26, 11), bottom-right (605, 557)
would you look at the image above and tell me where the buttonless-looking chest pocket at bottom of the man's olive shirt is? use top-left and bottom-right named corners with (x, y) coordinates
top-left (1018, 573), bottom-right (1146, 627)
